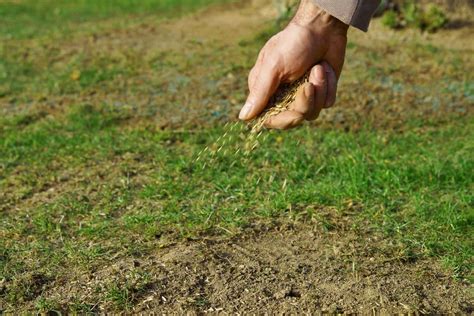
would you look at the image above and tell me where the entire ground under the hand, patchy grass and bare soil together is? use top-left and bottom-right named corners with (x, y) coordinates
top-left (0, 0), bottom-right (474, 313)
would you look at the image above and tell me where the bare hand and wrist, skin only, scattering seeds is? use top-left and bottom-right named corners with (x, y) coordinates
top-left (239, 0), bottom-right (348, 129)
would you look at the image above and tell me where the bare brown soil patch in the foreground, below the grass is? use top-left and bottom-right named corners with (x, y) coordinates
top-left (39, 218), bottom-right (474, 314)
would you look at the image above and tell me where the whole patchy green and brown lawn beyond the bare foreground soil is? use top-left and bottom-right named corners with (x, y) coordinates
top-left (0, 0), bottom-right (474, 312)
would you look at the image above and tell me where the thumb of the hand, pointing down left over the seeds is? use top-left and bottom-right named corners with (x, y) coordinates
top-left (239, 67), bottom-right (280, 121)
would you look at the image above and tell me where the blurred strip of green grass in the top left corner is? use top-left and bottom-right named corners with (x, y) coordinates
top-left (0, 0), bottom-right (230, 39)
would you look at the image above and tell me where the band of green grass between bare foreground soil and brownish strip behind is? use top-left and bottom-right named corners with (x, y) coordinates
top-left (0, 106), bottom-right (474, 288)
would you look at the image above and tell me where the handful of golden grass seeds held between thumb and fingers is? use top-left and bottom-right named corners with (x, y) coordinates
top-left (251, 70), bottom-right (311, 134)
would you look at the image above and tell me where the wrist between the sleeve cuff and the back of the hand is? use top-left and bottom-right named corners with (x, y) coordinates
top-left (290, 0), bottom-right (349, 36)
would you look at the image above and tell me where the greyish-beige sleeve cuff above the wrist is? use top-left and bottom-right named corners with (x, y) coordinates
top-left (313, 0), bottom-right (380, 31)
